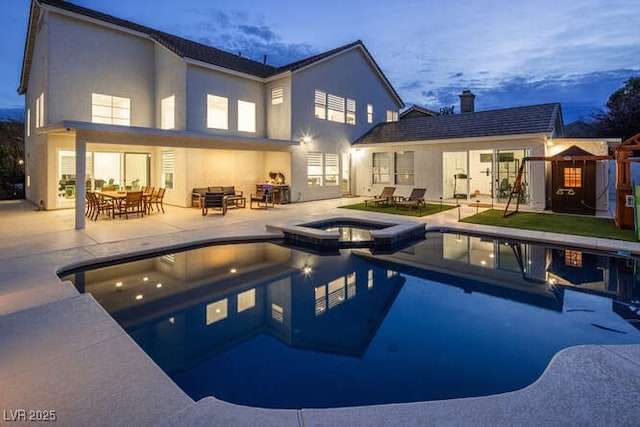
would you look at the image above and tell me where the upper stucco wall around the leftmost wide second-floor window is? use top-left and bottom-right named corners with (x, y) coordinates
top-left (47, 13), bottom-right (155, 127)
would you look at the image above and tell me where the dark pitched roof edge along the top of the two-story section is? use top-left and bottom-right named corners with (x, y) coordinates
top-left (18, 0), bottom-right (404, 105)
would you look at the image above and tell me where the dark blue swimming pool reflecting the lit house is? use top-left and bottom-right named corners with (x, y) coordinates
top-left (60, 233), bottom-right (640, 408)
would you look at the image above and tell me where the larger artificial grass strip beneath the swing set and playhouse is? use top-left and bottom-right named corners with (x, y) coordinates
top-left (460, 209), bottom-right (637, 242)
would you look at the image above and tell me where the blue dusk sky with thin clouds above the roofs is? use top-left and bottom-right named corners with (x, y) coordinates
top-left (0, 0), bottom-right (640, 123)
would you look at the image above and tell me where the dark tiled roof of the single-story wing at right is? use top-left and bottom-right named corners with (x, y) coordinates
top-left (354, 103), bottom-right (562, 144)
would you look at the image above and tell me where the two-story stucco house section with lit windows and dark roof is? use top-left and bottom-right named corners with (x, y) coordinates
top-left (18, 0), bottom-right (403, 228)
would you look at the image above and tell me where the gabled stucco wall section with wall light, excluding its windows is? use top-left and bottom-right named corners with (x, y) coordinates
top-left (291, 49), bottom-right (399, 201)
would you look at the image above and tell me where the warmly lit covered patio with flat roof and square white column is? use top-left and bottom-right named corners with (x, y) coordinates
top-left (33, 121), bottom-right (298, 230)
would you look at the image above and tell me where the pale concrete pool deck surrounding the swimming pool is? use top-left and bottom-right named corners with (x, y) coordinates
top-left (0, 198), bottom-right (640, 426)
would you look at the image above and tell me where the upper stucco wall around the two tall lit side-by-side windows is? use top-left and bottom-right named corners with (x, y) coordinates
top-left (187, 65), bottom-right (266, 138)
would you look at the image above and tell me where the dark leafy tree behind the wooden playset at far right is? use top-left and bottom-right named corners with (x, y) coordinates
top-left (594, 77), bottom-right (640, 141)
